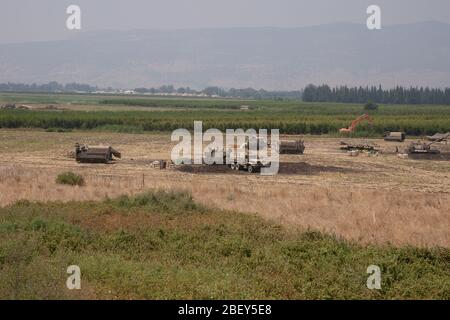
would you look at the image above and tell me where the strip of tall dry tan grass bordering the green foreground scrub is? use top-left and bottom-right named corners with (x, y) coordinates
top-left (0, 166), bottom-right (450, 247)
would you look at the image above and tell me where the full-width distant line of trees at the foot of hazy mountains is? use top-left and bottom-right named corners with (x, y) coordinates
top-left (0, 81), bottom-right (450, 105)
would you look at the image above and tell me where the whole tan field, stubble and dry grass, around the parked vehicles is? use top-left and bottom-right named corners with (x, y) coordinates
top-left (0, 130), bottom-right (450, 247)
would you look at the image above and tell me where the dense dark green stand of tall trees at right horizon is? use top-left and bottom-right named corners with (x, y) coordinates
top-left (302, 84), bottom-right (450, 105)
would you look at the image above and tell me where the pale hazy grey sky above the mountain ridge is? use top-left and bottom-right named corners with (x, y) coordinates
top-left (0, 0), bottom-right (450, 43)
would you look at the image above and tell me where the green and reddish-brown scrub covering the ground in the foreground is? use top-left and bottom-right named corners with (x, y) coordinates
top-left (0, 191), bottom-right (450, 299)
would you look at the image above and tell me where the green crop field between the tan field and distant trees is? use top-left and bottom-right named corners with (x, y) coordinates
top-left (0, 93), bottom-right (450, 136)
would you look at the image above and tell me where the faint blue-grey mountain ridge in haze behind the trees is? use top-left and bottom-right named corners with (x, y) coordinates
top-left (0, 22), bottom-right (450, 90)
